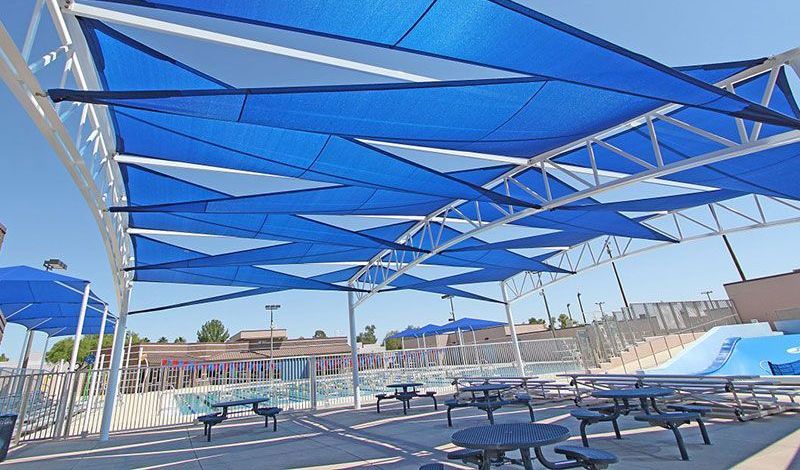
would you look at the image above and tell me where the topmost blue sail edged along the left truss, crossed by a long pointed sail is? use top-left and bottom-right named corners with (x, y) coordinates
top-left (75, 18), bottom-right (528, 205)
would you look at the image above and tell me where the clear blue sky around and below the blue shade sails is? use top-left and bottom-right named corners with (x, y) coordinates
top-left (0, 0), bottom-right (800, 357)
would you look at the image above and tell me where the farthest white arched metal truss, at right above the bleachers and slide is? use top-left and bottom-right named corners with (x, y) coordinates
top-left (506, 195), bottom-right (800, 303)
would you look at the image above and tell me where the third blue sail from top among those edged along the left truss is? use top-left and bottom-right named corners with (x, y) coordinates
top-left (133, 236), bottom-right (352, 291)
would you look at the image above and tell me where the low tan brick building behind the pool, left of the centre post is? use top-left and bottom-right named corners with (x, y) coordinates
top-left (109, 329), bottom-right (350, 367)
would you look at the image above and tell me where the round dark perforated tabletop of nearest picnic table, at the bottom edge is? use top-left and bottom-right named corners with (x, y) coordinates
top-left (452, 423), bottom-right (569, 470)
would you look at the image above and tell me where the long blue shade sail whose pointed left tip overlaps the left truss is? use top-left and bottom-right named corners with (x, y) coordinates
top-left (50, 77), bottom-right (800, 157)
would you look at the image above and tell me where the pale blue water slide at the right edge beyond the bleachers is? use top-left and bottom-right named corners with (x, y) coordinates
top-left (644, 323), bottom-right (800, 375)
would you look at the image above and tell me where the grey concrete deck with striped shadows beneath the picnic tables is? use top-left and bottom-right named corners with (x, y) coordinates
top-left (1, 400), bottom-right (800, 470)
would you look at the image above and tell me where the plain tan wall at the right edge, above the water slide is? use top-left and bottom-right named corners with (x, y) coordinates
top-left (725, 270), bottom-right (800, 327)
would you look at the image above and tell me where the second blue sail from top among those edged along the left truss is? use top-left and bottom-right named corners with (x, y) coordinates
top-left (120, 164), bottom-right (422, 251)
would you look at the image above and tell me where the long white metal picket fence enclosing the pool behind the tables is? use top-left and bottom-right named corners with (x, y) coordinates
top-left (0, 338), bottom-right (583, 441)
